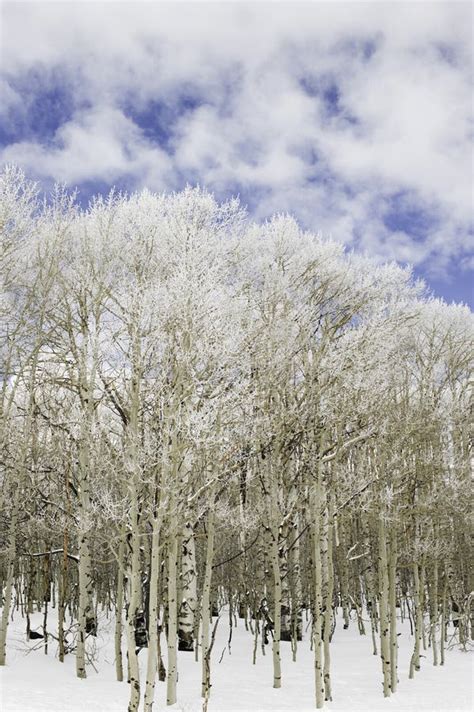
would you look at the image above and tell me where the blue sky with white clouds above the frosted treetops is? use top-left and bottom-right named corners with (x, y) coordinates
top-left (0, 0), bottom-right (474, 306)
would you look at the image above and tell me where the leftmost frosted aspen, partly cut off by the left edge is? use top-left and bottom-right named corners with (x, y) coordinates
top-left (0, 174), bottom-right (62, 666)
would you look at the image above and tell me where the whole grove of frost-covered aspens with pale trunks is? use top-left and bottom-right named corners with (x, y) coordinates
top-left (0, 167), bottom-right (474, 712)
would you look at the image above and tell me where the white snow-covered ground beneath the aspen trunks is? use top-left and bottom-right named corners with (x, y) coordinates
top-left (0, 614), bottom-right (473, 712)
